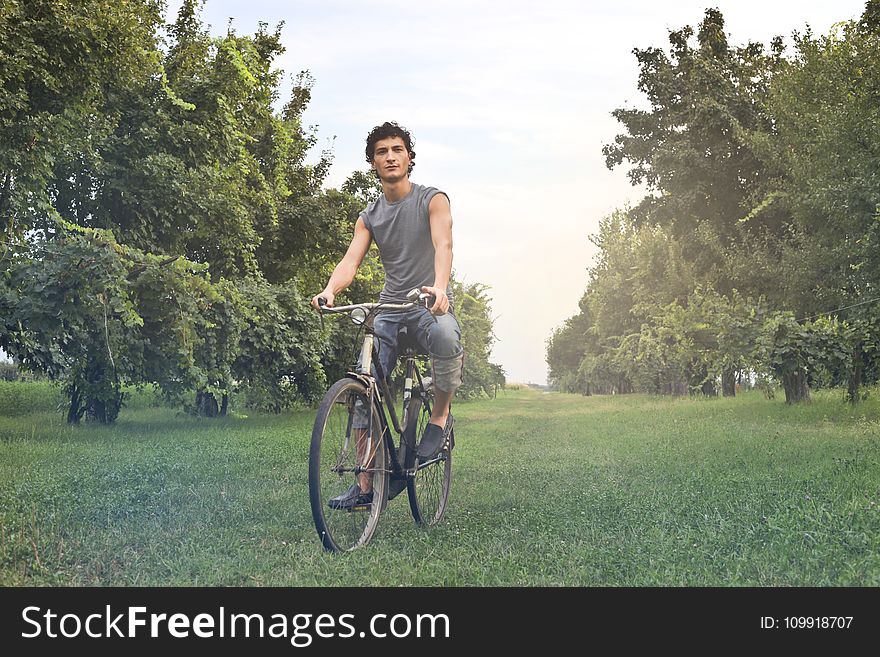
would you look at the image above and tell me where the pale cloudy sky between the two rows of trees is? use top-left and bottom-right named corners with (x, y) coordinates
top-left (168, 0), bottom-right (864, 383)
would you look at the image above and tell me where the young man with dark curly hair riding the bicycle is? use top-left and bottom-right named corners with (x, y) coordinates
top-left (312, 122), bottom-right (463, 508)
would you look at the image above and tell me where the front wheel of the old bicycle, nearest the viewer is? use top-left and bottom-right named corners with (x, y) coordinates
top-left (309, 379), bottom-right (388, 552)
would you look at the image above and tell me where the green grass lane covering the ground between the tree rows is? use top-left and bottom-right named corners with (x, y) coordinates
top-left (0, 383), bottom-right (880, 586)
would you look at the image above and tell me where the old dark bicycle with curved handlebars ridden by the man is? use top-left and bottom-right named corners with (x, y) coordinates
top-left (309, 290), bottom-right (455, 552)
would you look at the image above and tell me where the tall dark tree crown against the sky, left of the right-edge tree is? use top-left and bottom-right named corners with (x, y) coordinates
top-left (603, 9), bottom-right (782, 247)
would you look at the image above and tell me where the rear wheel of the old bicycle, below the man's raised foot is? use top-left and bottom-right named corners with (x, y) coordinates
top-left (406, 386), bottom-right (455, 527)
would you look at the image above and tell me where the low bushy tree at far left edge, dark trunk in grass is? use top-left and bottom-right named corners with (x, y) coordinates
top-left (2, 227), bottom-right (141, 423)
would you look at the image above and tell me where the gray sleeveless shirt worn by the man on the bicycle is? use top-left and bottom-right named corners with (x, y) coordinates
top-left (360, 183), bottom-right (452, 303)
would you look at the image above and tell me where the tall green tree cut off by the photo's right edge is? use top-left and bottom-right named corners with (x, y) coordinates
top-left (744, 0), bottom-right (880, 401)
